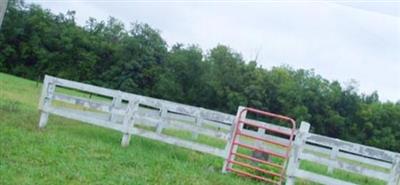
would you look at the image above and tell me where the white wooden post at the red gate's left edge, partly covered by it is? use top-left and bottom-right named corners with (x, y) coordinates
top-left (222, 106), bottom-right (247, 173)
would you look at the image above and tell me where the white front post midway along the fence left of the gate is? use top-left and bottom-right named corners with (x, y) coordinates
top-left (121, 100), bottom-right (139, 147)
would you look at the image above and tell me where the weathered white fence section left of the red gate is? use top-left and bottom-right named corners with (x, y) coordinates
top-left (39, 76), bottom-right (234, 157)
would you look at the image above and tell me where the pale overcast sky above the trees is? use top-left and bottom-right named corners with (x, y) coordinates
top-left (27, 0), bottom-right (400, 101)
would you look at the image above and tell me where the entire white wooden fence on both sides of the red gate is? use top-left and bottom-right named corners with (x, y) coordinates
top-left (39, 75), bottom-right (400, 185)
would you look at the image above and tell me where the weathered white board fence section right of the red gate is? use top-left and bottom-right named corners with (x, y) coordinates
top-left (286, 124), bottom-right (400, 185)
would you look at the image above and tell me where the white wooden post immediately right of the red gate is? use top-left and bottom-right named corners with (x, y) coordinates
top-left (286, 122), bottom-right (310, 185)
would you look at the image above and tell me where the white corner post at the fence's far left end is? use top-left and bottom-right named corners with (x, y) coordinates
top-left (39, 76), bottom-right (56, 128)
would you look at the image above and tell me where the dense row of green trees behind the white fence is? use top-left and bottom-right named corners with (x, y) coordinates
top-left (0, 0), bottom-right (400, 151)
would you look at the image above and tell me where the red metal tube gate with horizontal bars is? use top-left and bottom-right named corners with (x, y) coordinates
top-left (224, 108), bottom-right (296, 184)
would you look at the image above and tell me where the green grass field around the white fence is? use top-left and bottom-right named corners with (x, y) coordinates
top-left (0, 73), bottom-right (383, 185)
